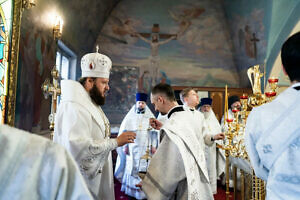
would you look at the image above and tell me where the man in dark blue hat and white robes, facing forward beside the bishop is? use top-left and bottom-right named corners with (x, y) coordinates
top-left (115, 93), bottom-right (158, 199)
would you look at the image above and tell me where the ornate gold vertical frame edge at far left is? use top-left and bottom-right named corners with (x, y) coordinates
top-left (5, 0), bottom-right (22, 126)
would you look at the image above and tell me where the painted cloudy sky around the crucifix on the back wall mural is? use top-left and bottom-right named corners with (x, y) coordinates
top-left (96, 0), bottom-right (238, 87)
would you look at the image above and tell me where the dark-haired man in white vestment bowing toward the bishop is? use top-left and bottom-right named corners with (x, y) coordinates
top-left (142, 84), bottom-right (224, 200)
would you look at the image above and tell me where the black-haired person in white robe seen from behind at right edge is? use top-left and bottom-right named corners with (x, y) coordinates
top-left (245, 32), bottom-right (300, 200)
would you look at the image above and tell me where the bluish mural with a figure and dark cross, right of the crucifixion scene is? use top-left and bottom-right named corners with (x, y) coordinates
top-left (225, 0), bottom-right (269, 87)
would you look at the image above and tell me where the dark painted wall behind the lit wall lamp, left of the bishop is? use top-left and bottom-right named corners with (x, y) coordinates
top-left (15, 0), bottom-right (119, 134)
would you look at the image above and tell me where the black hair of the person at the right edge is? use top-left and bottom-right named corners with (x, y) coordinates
top-left (281, 32), bottom-right (300, 81)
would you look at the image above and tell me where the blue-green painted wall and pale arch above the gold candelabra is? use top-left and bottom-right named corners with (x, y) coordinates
top-left (224, 0), bottom-right (300, 87)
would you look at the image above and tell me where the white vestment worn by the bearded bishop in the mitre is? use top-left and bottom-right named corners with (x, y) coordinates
top-left (53, 80), bottom-right (118, 200)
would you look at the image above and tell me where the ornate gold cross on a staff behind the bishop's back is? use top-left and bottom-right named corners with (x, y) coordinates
top-left (41, 66), bottom-right (61, 136)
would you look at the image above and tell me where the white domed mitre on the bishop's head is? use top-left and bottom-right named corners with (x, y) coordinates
top-left (81, 48), bottom-right (112, 78)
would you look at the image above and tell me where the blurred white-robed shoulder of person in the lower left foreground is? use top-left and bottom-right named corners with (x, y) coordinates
top-left (0, 125), bottom-right (93, 200)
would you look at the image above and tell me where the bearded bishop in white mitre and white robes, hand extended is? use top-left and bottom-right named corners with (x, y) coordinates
top-left (53, 52), bottom-right (135, 200)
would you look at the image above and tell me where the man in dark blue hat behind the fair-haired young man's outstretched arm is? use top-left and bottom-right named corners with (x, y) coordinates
top-left (200, 98), bottom-right (225, 194)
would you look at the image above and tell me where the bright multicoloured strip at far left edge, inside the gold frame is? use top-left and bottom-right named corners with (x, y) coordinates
top-left (0, 0), bottom-right (12, 123)
